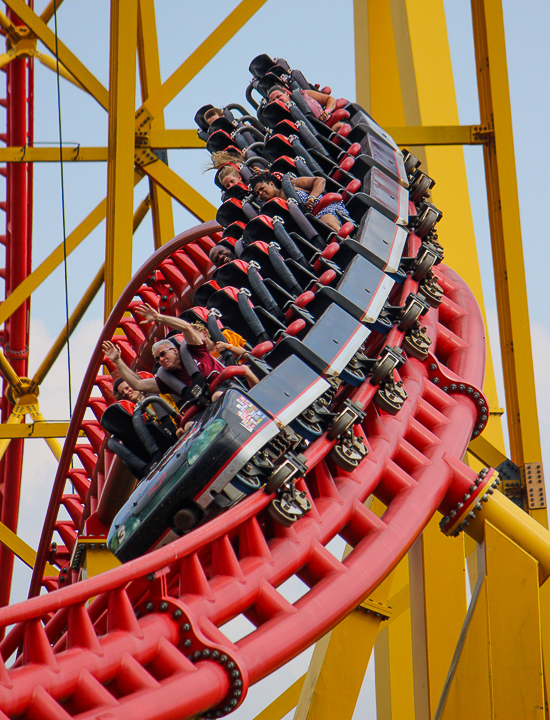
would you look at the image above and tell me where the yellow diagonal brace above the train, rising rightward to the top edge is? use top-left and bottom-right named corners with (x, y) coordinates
top-left (139, 0), bottom-right (266, 118)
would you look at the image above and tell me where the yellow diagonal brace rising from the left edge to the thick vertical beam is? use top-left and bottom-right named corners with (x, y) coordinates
top-left (0, 173), bottom-right (143, 325)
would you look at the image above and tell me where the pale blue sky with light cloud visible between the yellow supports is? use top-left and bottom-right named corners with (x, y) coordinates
top-left (4, 0), bottom-right (550, 720)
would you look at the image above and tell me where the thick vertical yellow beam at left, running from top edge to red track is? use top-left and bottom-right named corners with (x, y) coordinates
top-left (105, 0), bottom-right (138, 319)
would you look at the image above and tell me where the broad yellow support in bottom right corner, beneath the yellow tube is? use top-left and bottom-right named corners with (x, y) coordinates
top-left (435, 522), bottom-right (547, 720)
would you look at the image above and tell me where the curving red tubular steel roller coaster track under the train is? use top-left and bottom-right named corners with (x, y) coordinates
top-left (0, 217), bottom-right (490, 720)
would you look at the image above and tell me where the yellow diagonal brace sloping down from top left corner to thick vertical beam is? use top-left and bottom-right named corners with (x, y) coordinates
top-left (5, 0), bottom-right (109, 110)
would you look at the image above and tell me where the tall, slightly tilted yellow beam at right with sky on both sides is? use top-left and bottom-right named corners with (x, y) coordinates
top-left (472, 0), bottom-right (547, 526)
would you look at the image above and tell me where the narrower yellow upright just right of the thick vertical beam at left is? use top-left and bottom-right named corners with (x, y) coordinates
top-left (138, 0), bottom-right (174, 249)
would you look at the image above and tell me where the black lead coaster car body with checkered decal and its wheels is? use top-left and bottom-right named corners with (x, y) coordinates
top-left (107, 389), bottom-right (311, 562)
